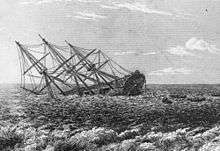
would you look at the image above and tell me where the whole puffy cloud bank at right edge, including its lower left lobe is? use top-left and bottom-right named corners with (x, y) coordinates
top-left (165, 37), bottom-right (220, 57)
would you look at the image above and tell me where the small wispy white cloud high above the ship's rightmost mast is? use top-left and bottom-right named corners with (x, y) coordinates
top-left (73, 12), bottom-right (106, 20)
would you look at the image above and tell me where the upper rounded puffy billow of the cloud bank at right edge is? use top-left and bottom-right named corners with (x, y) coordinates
top-left (185, 37), bottom-right (220, 53)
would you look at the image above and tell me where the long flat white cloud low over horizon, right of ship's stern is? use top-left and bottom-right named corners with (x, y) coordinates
top-left (149, 67), bottom-right (192, 76)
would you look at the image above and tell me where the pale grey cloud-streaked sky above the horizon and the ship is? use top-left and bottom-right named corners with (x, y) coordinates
top-left (0, 0), bottom-right (220, 84)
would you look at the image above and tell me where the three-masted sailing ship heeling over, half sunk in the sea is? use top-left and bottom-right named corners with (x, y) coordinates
top-left (15, 35), bottom-right (145, 97)
